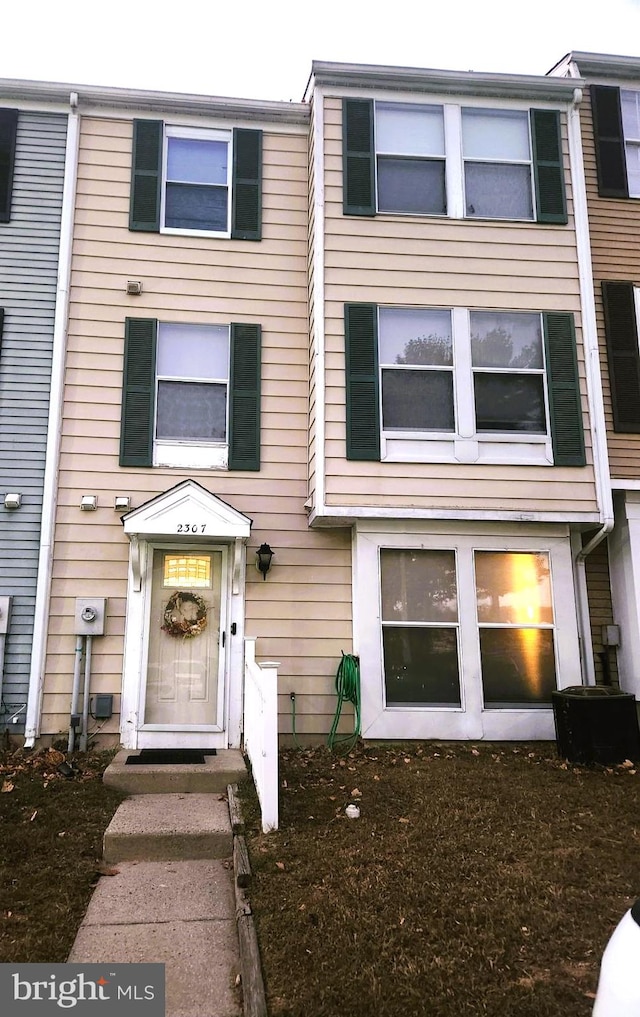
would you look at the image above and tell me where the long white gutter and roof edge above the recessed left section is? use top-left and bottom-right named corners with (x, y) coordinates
top-left (0, 78), bottom-right (309, 124)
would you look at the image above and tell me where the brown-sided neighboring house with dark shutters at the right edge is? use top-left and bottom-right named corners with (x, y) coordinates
top-left (549, 52), bottom-right (640, 698)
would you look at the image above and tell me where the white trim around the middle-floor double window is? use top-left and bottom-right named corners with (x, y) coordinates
top-left (377, 307), bottom-right (553, 466)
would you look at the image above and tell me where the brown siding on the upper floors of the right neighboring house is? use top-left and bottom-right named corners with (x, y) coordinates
top-left (580, 88), bottom-right (640, 480)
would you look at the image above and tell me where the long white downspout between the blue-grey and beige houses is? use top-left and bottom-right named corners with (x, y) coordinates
top-left (24, 92), bottom-right (79, 749)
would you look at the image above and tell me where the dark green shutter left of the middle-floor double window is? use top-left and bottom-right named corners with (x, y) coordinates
top-left (345, 304), bottom-right (380, 461)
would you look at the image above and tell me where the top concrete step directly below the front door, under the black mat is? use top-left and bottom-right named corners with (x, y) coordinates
top-left (103, 749), bottom-right (246, 794)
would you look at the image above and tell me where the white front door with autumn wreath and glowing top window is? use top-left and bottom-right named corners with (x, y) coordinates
top-left (137, 546), bottom-right (227, 749)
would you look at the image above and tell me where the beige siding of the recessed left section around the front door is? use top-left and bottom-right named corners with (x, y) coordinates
top-left (43, 118), bottom-right (352, 737)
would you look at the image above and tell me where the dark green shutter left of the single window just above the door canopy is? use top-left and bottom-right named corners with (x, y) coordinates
top-left (120, 318), bottom-right (158, 466)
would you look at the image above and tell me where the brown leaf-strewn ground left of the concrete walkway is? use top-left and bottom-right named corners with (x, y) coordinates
top-left (0, 749), bottom-right (123, 963)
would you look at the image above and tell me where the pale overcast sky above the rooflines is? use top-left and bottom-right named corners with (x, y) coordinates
top-left (0, 0), bottom-right (640, 102)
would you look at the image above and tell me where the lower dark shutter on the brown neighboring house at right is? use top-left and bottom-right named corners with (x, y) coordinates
top-left (602, 282), bottom-right (640, 434)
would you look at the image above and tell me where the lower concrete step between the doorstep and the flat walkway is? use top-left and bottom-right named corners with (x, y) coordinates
top-left (103, 793), bottom-right (233, 863)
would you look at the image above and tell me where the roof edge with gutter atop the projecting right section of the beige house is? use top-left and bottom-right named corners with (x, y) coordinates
top-left (304, 60), bottom-right (582, 102)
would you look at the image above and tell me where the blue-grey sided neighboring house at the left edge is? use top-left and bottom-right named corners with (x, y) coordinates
top-left (0, 80), bottom-right (74, 734)
